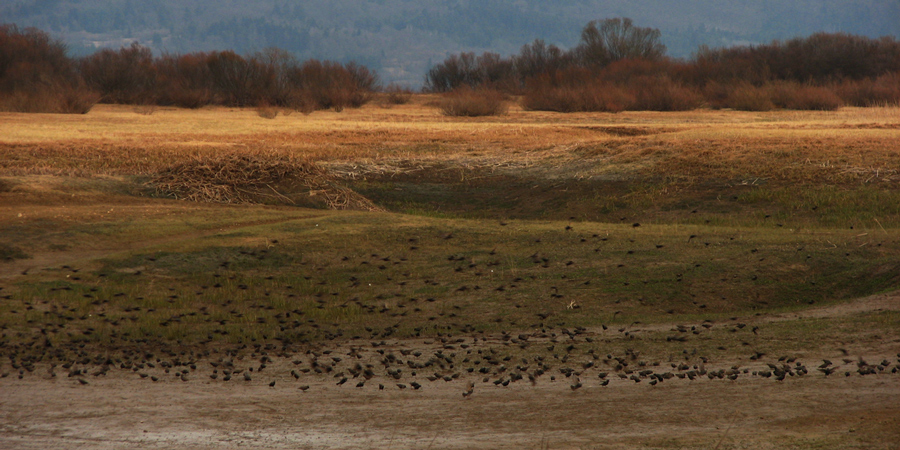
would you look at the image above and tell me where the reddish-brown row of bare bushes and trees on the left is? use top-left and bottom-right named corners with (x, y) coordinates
top-left (0, 25), bottom-right (378, 113)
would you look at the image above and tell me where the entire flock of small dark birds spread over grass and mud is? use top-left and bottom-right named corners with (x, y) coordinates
top-left (0, 223), bottom-right (900, 398)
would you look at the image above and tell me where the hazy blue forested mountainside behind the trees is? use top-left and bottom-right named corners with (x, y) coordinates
top-left (0, 0), bottom-right (900, 87)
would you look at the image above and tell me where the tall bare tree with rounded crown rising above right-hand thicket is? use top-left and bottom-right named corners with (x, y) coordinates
top-left (576, 18), bottom-right (666, 67)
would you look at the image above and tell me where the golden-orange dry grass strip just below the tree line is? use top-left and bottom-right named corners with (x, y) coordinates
top-left (0, 99), bottom-right (900, 212)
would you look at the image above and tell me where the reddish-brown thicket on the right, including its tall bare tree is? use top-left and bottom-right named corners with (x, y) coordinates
top-left (425, 18), bottom-right (900, 112)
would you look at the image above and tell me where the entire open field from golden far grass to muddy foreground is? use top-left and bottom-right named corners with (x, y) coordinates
top-left (0, 99), bottom-right (900, 450)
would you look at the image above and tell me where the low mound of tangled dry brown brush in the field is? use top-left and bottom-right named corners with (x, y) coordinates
top-left (147, 154), bottom-right (380, 211)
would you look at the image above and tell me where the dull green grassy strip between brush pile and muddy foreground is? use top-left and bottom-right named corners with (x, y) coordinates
top-left (0, 209), bottom-right (900, 352)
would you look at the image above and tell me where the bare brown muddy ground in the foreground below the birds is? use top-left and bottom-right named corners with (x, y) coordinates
top-left (0, 295), bottom-right (900, 449)
